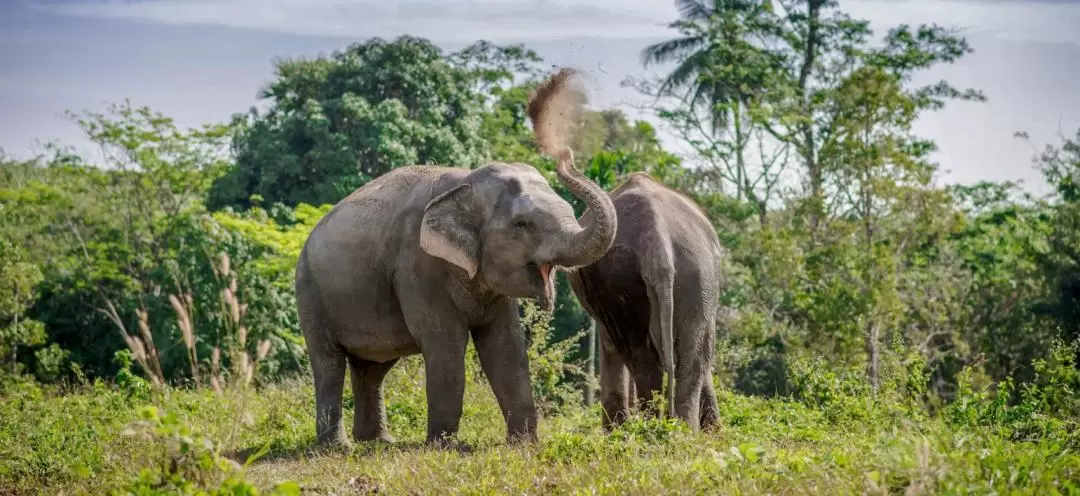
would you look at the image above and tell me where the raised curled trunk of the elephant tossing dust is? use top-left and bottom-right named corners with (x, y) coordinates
top-left (554, 147), bottom-right (618, 267)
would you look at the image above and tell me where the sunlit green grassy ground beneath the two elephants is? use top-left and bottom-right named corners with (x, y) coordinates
top-left (0, 360), bottom-right (1080, 495)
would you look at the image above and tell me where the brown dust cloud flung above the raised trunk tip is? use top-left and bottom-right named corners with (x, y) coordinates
top-left (528, 67), bottom-right (586, 157)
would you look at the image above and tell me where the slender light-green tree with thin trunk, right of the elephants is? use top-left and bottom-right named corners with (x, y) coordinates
top-left (821, 66), bottom-right (945, 391)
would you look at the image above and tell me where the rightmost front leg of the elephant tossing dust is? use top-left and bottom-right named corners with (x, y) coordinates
top-left (472, 298), bottom-right (537, 443)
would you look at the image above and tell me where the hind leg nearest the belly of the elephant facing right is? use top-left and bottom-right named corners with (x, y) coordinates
top-left (349, 356), bottom-right (397, 443)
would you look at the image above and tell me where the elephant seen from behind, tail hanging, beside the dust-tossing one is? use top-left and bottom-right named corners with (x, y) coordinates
top-left (567, 172), bottom-right (723, 431)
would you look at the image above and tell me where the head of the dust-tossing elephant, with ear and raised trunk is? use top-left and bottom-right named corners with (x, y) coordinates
top-left (420, 148), bottom-right (616, 310)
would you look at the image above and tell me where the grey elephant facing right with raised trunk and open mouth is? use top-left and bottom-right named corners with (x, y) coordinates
top-left (295, 144), bottom-right (617, 450)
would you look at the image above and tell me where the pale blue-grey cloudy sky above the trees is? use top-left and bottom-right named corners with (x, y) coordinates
top-left (0, 0), bottom-right (1080, 192)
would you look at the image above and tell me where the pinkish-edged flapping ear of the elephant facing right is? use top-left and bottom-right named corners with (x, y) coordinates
top-left (420, 185), bottom-right (480, 279)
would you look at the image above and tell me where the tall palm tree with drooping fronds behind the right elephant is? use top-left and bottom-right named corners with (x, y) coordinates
top-left (624, 0), bottom-right (786, 213)
